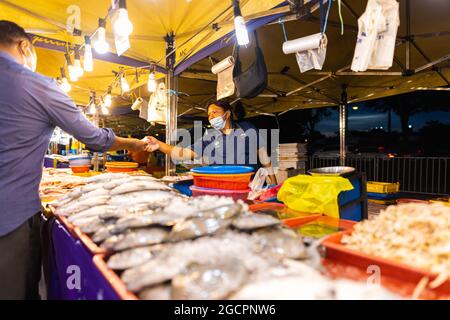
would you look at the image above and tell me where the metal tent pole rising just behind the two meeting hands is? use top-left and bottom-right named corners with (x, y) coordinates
top-left (165, 33), bottom-right (178, 176)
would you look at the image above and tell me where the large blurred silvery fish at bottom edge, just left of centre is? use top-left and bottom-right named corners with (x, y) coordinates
top-left (172, 259), bottom-right (248, 300)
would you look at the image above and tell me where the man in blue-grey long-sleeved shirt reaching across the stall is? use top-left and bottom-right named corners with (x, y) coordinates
top-left (0, 20), bottom-right (152, 299)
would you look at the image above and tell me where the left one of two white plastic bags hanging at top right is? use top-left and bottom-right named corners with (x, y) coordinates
top-left (351, 0), bottom-right (386, 72)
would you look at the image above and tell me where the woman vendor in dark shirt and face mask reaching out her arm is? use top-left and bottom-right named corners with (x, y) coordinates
top-left (148, 100), bottom-right (277, 184)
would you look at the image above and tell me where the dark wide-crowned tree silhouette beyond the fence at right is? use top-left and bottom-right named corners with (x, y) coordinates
top-left (366, 91), bottom-right (450, 141)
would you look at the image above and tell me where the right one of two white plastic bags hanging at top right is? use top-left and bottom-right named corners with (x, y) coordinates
top-left (369, 0), bottom-right (400, 70)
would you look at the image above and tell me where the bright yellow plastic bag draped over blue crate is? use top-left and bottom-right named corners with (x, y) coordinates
top-left (278, 175), bottom-right (353, 219)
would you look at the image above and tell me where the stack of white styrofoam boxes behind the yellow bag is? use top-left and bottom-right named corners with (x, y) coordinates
top-left (276, 143), bottom-right (306, 183)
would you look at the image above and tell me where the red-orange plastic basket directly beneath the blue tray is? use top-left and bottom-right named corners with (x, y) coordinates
top-left (192, 173), bottom-right (253, 190)
